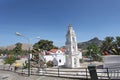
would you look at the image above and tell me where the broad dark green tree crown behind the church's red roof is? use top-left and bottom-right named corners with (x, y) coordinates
top-left (33, 40), bottom-right (57, 50)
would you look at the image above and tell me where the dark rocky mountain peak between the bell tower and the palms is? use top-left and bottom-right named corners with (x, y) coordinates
top-left (78, 37), bottom-right (102, 50)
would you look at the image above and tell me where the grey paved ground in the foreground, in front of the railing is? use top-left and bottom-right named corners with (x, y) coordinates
top-left (0, 70), bottom-right (78, 80)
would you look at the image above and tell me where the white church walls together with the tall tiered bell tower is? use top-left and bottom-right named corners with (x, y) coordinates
top-left (40, 25), bottom-right (82, 68)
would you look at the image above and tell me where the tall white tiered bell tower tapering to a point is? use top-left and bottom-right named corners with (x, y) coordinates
top-left (65, 25), bottom-right (81, 68)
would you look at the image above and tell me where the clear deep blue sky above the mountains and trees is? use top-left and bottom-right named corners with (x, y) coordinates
top-left (0, 0), bottom-right (120, 46)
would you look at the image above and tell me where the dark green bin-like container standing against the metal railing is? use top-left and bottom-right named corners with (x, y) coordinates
top-left (88, 64), bottom-right (98, 80)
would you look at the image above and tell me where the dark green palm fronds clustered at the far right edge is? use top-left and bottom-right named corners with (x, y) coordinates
top-left (101, 36), bottom-right (120, 55)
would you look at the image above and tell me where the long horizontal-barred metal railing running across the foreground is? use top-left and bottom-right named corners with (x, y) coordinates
top-left (0, 65), bottom-right (120, 80)
